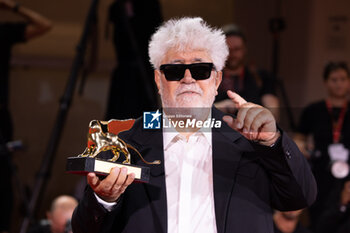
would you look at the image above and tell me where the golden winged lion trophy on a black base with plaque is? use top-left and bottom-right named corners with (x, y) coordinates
top-left (66, 119), bottom-right (160, 183)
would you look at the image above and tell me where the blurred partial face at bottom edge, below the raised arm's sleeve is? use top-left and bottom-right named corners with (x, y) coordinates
top-left (273, 209), bottom-right (311, 233)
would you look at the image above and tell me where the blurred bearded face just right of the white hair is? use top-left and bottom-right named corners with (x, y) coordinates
top-left (226, 36), bottom-right (246, 70)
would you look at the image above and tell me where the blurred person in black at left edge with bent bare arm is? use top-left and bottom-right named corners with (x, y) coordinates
top-left (0, 0), bottom-right (52, 232)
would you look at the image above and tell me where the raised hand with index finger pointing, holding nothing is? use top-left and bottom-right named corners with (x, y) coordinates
top-left (223, 91), bottom-right (280, 146)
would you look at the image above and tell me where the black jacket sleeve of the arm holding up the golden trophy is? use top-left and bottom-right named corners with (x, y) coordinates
top-left (72, 186), bottom-right (122, 233)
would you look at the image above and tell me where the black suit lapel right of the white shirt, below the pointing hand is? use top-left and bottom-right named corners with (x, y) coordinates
top-left (212, 108), bottom-right (242, 233)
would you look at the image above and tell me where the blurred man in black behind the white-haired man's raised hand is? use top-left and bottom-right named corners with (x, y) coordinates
top-left (215, 24), bottom-right (279, 118)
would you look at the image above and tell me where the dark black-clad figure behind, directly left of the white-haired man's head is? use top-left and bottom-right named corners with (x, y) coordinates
top-left (106, 0), bottom-right (163, 120)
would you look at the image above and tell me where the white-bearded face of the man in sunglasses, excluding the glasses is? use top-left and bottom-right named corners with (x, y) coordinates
top-left (155, 49), bottom-right (222, 108)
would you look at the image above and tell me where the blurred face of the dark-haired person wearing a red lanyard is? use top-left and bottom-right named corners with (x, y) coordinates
top-left (325, 69), bottom-right (350, 98)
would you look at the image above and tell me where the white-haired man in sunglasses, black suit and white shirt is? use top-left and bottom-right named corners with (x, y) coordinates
top-left (72, 18), bottom-right (316, 233)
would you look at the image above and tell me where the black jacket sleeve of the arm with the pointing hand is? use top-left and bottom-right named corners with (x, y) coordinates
top-left (254, 132), bottom-right (317, 211)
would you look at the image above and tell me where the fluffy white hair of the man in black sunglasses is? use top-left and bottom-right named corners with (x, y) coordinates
top-left (148, 17), bottom-right (228, 70)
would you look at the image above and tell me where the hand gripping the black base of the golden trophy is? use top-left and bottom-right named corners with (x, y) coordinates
top-left (87, 167), bottom-right (135, 202)
